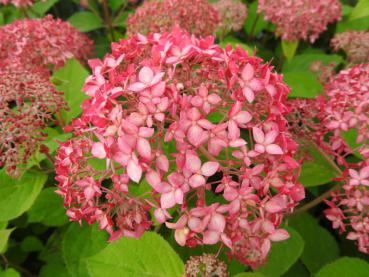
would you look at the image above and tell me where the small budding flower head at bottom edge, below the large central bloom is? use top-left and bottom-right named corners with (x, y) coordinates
top-left (183, 253), bottom-right (229, 277)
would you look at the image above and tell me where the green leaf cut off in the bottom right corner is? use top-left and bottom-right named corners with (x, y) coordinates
top-left (316, 257), bottom-right (369, 277)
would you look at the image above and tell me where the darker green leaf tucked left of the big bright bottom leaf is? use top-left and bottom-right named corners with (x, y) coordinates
top-left (62, 223), bottom-right (109, 277)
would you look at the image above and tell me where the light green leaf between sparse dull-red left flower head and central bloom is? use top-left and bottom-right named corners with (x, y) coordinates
top-left (52, 59), bottom-right (89, 123)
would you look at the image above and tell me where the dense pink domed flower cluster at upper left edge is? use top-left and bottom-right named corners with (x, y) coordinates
top-left (0, 15), bottom-right (93, 69)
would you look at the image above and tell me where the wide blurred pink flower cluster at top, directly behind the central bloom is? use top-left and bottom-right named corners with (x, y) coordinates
top-left (127, 0), bottom-right (220, 36)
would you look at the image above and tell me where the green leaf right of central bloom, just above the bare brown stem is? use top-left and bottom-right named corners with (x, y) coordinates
top-left (299, 141), bottom-right (339, 187)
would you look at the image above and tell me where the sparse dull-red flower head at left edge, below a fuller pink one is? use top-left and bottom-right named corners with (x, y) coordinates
top-left (0, 68), bottom-right (65, 176)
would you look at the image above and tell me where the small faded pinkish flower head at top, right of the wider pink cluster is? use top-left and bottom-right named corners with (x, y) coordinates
top-left (214, 0), bottom-right (247, 33)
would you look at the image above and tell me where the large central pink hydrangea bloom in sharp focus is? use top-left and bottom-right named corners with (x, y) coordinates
top-left (55, 29), bottom-right (304, 266)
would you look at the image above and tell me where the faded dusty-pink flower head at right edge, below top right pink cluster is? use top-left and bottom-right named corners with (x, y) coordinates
top-left (331, 31), bottom-right (369, 63)
